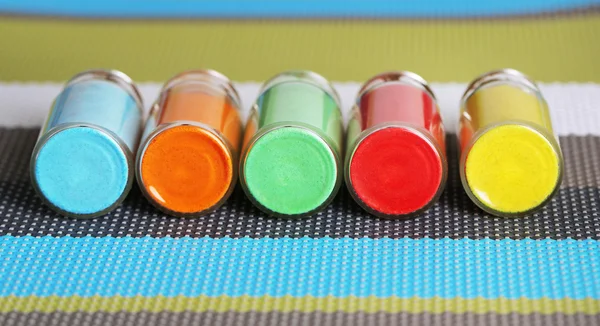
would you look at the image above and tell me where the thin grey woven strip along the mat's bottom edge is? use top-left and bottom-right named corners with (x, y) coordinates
top-left (0, 312), bottom-right (600, 326)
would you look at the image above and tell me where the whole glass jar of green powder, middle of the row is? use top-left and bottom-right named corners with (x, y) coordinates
top-left (240, 71), bottom-right (343, 217)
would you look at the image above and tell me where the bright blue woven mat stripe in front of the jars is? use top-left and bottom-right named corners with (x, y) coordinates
top-left (0, 236), bottom-right (600, 299)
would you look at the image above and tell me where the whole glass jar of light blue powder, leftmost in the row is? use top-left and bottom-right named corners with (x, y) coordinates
top-left (30, 70), bottom-right (143, 218)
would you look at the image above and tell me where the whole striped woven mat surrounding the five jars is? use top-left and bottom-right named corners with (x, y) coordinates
top-left (0, 0), bottom-right (600, 320)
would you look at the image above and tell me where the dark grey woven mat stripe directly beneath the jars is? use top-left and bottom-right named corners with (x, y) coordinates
top-left (0, 129), bottom-right (600, 240)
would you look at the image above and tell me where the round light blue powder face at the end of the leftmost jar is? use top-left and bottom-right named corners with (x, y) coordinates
top-left (34, 127), bottom-right (129, 215)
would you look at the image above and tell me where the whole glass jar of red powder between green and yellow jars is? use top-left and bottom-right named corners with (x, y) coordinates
top-left (345, 71), bottom-right (448, 218)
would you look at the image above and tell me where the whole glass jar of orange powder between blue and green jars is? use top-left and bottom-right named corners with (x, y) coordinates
top-left (136, 70), bottom-right (242, 216)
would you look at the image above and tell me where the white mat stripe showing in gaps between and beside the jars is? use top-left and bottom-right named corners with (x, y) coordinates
top-left (0, 82), bottom-right (600, 136)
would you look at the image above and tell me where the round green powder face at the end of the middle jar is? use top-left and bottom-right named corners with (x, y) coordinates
top-left (246, 127), bottom-right (337, 215)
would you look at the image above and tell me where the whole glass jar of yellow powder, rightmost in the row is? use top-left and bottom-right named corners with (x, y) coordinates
top-left (459, 69), bottom-right (563, 217)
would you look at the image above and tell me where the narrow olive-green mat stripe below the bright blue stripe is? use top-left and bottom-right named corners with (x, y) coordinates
top-left (0, 296), bottom-right (600, 315)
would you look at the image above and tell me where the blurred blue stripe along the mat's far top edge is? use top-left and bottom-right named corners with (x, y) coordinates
top-left (0, 0), bottom-right (600, 18)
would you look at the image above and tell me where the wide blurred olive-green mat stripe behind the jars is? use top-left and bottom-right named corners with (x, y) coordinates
top-left (0, 13), bottom-right (600, 82)
